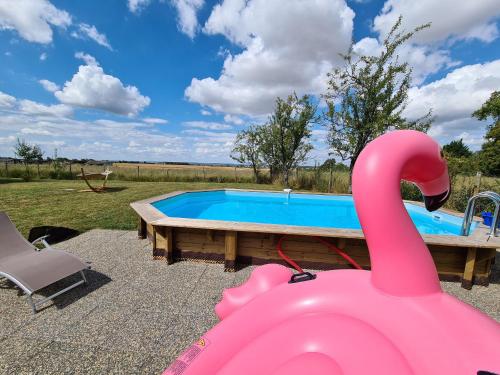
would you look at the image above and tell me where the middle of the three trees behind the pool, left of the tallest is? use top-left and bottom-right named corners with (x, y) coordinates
top-left (262, 94), bottom-right (316, 187)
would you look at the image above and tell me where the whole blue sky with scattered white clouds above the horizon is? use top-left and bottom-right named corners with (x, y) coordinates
top-left (0, 0), bottom-right (500, 163)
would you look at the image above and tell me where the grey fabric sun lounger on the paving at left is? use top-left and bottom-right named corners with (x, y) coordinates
top-left (0, 212), bottom-right (90, 313)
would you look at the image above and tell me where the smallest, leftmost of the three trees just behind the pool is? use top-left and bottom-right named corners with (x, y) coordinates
top-left (231, 126), bottom-right (263, 183)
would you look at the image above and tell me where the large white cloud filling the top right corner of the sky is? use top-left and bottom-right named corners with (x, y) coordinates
top-left (348, 0), bottom-right (500, 84)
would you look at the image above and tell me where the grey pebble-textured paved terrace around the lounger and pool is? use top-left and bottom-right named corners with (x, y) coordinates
top-left (0, 230), bottom-right (500, 375)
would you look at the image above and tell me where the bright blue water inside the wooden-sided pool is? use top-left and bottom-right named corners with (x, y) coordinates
top-left (153, 190), bottom-right (476, 235)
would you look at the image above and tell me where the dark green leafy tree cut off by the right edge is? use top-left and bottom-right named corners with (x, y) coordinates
top-left (472, 91), bottom-right (500, 176)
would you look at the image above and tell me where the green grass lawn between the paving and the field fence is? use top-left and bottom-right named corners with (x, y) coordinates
top-left (0, 179), bottom-right (277, 236)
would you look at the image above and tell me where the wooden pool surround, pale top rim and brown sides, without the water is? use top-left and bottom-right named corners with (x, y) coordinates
top-left (131, 189), bottom-right (500, 289)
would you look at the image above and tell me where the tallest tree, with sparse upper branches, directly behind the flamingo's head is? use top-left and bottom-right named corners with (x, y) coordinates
top-left (324, 17), bottom-right (432, 173)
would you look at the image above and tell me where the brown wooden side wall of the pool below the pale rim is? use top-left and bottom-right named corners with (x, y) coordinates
top-left (147, 225), bottom-right (496, 287)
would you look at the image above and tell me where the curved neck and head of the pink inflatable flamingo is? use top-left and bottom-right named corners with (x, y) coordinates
top-left (352, 130), bottom-right (450, 296)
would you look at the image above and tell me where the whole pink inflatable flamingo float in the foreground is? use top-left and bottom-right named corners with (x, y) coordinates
top-left (164, 131), bottom-right (500, 375)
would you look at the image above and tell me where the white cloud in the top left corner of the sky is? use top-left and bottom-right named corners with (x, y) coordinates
top-left (0, 0), bottom-right (71, 44)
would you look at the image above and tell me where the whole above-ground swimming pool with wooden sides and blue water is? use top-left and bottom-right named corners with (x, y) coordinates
top-left (131, 189), bottom-right (500, 287)
